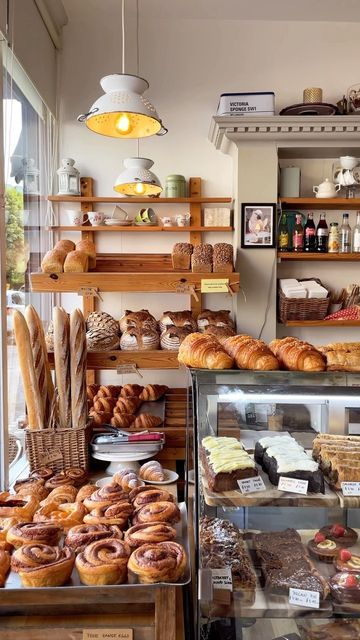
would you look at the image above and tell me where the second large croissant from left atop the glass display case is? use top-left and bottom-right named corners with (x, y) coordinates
top-left (222, 336), bottom-right (279, 371)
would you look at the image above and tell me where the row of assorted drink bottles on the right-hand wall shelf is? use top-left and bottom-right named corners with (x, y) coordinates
top-left (278, 211), bottom-right (360, 253)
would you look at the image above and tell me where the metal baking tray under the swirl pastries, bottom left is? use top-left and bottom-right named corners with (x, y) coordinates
top-left (0, 502), bottom-right (191, 596)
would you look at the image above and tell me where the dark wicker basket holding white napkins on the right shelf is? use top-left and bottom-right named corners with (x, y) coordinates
top-left (278, 278), bottom-right (330, 324)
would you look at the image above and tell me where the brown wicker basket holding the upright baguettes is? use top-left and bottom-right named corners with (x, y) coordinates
top-left (25, 423), bottom-right (92, 472)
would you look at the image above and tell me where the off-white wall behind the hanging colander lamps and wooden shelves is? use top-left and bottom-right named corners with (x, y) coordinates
top-left (60, 0), bottom-right (360, 381)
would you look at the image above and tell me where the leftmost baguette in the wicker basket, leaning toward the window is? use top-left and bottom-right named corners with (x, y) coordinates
top-left (13, 309), bottom-right (44, 429)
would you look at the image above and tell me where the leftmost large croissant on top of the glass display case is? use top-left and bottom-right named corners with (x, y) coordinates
top-left (178, 333), bottom-right (234, 369)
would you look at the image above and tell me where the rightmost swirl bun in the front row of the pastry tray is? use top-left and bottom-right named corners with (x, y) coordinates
top-left (128, 542), bottom-right (187, 584)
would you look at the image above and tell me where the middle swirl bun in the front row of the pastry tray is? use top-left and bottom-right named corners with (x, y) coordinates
top-left (75, 538), bottom-right (130, 585)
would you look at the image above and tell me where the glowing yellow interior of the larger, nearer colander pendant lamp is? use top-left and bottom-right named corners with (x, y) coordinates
top-left (86, 111), bottom-right (161, 138)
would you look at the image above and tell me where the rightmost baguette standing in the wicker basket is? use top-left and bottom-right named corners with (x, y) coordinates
top-left (70, 309), bottom-right (87, 429)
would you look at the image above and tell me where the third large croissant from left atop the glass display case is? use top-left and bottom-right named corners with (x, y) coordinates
top-left (269, 337), bottom-right (326, 371)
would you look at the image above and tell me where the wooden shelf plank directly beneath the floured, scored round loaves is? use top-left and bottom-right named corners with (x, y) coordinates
top-left (49, 350), bottom-right (179, 371)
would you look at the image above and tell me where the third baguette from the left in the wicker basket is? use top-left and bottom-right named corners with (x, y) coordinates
top-left (53, 307), bottom-right (71, 429)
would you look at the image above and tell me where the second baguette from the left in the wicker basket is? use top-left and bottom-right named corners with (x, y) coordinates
top-left (25, 305), bottom-right (54, 426)
